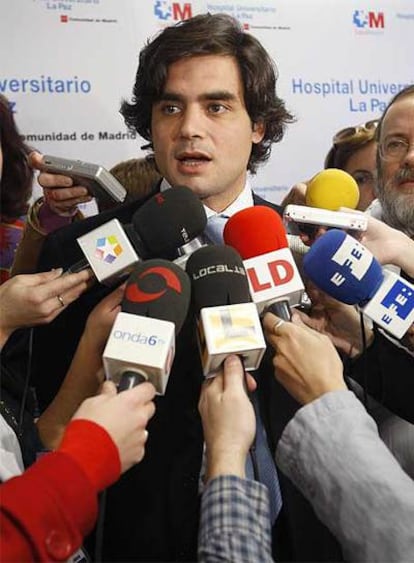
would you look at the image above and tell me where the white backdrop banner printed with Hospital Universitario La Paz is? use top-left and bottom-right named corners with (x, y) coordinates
top-left (0, 0), bottom-right (414, 209)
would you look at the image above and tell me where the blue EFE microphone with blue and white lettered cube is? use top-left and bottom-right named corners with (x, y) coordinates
top-left (303, 229), bottom-right (414, 338)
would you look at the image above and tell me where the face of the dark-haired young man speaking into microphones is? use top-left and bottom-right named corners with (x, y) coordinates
top-left (151, 55), bottom-right (264, 211)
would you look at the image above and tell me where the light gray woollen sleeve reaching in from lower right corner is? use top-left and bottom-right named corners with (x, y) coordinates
top-left (276, 391), bottom-right (414, 562)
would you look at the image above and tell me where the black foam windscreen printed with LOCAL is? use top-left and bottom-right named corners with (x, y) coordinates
top-left (186, 244), bottom-right (252, 313)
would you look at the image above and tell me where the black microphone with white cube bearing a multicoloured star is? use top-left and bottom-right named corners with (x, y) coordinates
top-left (68, 186), bottom-right (207, 285)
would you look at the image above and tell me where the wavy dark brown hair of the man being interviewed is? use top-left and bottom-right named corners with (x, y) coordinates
top-left (120, 14), bottom-right (294, 173)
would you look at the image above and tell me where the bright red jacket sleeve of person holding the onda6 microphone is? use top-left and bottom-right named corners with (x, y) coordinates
top-left (0, 420), bottom-right (120, 563)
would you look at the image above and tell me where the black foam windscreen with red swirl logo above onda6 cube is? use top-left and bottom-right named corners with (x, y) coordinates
top-left (121, 259), bottom-right (191, 335)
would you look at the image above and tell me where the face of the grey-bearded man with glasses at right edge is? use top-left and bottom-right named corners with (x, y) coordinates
top-left (378, 94), bottom-right (414, 237)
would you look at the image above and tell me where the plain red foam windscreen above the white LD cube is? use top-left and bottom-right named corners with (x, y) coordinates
top-left (223, 205), bottom-right (288, 260)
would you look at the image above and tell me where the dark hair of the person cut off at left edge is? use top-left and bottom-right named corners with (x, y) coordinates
top-left (0, 94), bottom-right (33, 219)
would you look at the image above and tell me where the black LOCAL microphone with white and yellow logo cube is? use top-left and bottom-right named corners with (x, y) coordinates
top-left (186, 245), bottom-right (266, 377)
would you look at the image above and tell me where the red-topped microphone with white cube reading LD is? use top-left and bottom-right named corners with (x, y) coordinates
top-left (223, 205), bottom-right (305, 320)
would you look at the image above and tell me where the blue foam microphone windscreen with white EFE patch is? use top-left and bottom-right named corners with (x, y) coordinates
top-left (303, 229), bottom-right (383, 305)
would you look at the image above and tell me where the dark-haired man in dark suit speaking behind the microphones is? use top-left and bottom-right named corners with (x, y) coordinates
top-left (4, 14), bottom-right (340, 561)
